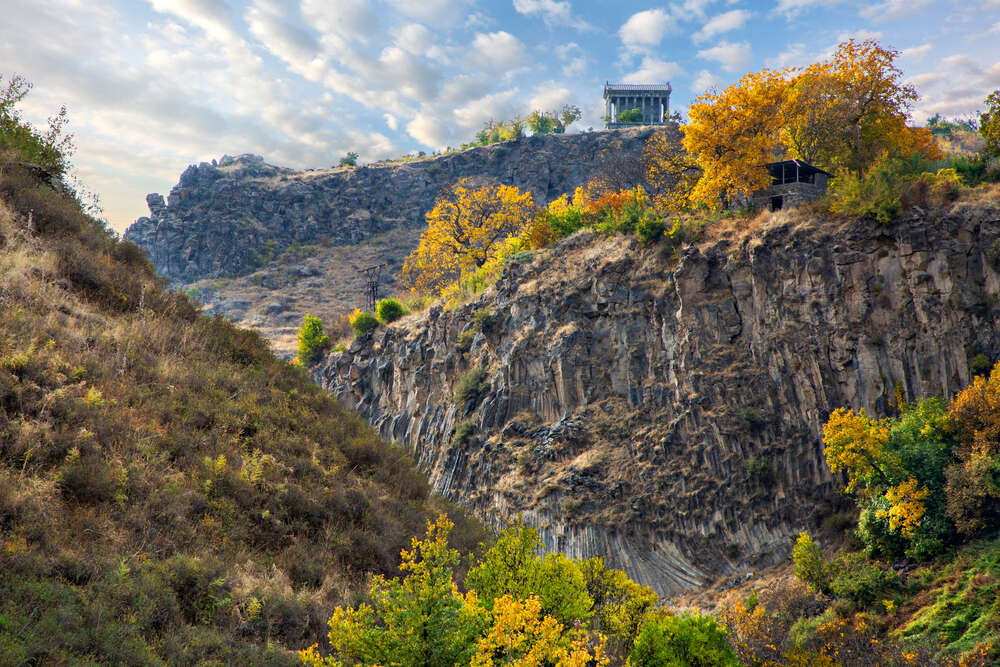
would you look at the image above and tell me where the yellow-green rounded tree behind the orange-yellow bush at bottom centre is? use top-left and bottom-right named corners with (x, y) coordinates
top-left (465, 523), bottom-right (594, 625)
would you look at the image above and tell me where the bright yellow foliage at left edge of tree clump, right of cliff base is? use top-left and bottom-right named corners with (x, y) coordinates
top-left (823, 408), bottom-right (889, 492)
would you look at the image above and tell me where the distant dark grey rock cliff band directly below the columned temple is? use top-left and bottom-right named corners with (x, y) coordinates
top-left (125, 128), bottom-right (652, 283)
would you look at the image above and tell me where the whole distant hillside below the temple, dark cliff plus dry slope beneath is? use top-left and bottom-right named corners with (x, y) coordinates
top-left (125, 128), bottom-right (651, 357)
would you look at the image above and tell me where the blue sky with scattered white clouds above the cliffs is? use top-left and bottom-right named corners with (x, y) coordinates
top-left (0, 0), bottom-right (1000, 231)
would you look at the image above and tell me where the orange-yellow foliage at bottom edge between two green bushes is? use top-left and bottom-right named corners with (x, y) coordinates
top-left (471, 595), bottom-right (608, 667)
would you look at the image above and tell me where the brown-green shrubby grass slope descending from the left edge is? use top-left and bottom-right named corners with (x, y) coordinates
top-left (0, 160), bottom-right (481, 664)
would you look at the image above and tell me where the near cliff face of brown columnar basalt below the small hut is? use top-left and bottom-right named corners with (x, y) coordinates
top-left (314, 201), bottom-right (1000, 593)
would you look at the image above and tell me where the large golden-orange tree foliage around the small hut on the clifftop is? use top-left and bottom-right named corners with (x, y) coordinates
top-left (668, 39), bottom-right (942, 208)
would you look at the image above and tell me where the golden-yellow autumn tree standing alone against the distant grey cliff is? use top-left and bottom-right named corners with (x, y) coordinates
top-left (400, 179), bottom-right (536, 293)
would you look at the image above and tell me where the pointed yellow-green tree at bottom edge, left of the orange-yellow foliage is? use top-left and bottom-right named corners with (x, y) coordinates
top-left (300, 515), bottom-right (489, 667)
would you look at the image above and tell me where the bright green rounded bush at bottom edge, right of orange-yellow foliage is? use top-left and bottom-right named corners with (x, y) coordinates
top-left (629, 612), bottom-right (740, 667)
